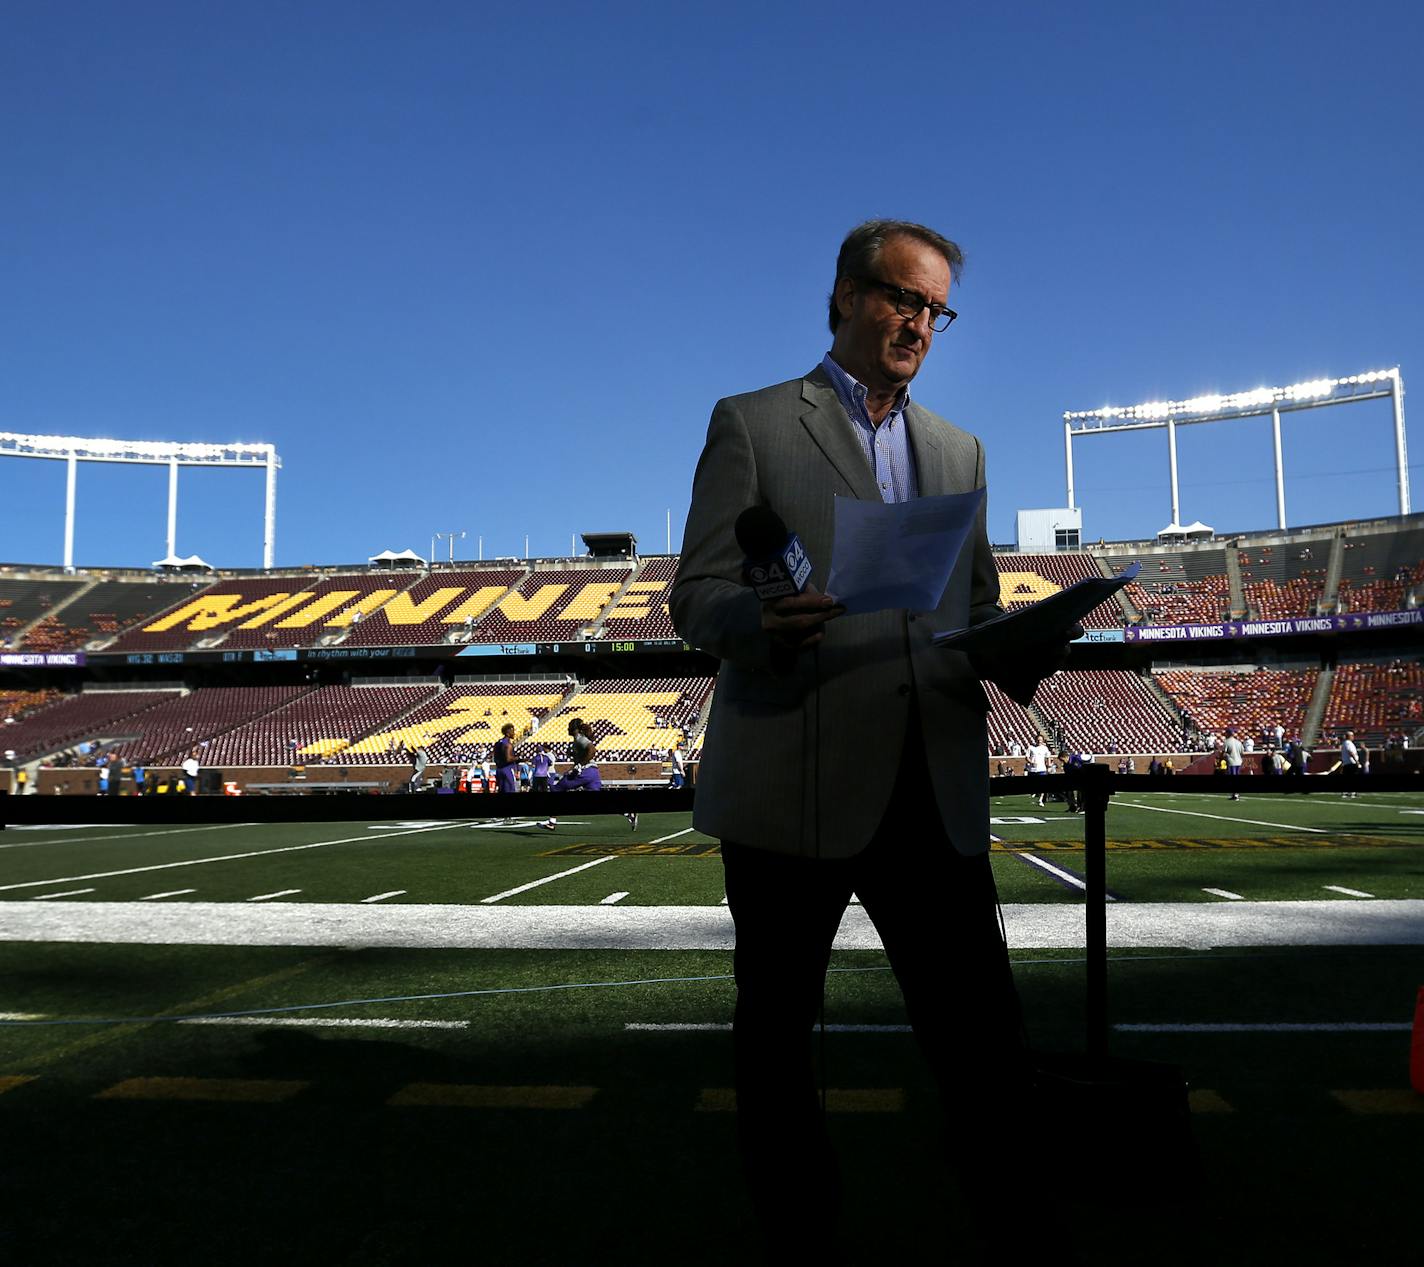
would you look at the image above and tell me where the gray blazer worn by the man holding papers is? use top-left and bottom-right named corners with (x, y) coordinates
top-left (669, 366), bottom-right (1000, 858)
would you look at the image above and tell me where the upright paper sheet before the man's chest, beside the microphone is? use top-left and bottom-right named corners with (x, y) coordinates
top-left (826, 488), bottom-right (984, 614)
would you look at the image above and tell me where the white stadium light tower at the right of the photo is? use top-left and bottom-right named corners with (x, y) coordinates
top-left (1064, 366), bottom-right (1410, 530)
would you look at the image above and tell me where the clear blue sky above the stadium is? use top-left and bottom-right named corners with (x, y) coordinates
top-left (0, 0), bottom-right (1424, 567)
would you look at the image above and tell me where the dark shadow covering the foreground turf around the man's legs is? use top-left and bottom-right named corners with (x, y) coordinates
top-left (0, 947), bottom-right (1424, 1267)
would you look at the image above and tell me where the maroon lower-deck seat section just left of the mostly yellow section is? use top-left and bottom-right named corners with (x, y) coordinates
top-left (204, 683), bottom-right (441, 766)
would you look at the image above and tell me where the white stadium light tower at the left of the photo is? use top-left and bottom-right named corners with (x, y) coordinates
top-left (0, 431), bottom-right (282, 568)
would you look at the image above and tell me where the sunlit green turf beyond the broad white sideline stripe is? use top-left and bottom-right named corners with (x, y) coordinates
top-left (0, 793), bottom-right (1424, 905)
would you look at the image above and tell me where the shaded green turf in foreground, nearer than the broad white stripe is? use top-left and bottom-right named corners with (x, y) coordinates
top-left (0, 945), bottom-right (1424, 1267)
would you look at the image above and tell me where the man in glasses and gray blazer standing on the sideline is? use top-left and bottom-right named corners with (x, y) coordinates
top-left (669, 221), bottom-right (1057, 1254)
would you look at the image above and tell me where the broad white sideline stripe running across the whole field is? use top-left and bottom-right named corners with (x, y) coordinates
top-left (0, 899), bottom-right (1424, 951)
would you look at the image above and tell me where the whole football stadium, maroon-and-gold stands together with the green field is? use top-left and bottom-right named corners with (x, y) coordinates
top-left (0, 360), bottom-right (1424, 1264)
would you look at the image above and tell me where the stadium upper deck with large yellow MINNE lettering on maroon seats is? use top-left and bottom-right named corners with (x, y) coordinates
top-left (0, 515), bottom-right (1424, 659)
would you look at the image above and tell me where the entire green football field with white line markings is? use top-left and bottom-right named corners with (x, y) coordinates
top-left (0, 793), bottom-right (1424, 1264)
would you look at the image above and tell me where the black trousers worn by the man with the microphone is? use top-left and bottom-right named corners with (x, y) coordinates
top-left (722, 727), bottom-right (1024, 1240)
